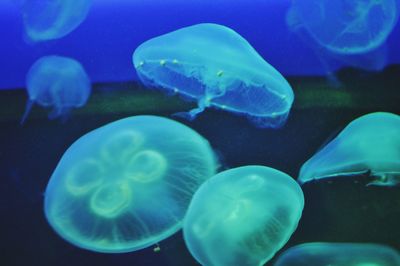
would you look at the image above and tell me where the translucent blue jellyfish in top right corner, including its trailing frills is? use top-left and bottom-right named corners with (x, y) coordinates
top-left (286, 0), bottom-right (399, 75)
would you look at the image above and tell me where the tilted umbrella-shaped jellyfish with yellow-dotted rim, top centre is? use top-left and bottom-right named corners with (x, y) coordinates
top-left (133, 23), bottom-right (294, 128)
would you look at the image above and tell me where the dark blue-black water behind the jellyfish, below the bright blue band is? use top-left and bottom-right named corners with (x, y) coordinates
top-left (0, 66), bottom-right (400, 266)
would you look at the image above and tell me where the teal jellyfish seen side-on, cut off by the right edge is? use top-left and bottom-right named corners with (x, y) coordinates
top-left (298, 112), bottom-right (400, 186)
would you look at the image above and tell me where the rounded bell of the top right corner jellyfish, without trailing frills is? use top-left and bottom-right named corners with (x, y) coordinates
top-left (287, 0), bottom-right (399, 55)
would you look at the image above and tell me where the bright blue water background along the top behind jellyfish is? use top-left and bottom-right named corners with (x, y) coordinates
top-left (0, 0), bottom-right (400, 89)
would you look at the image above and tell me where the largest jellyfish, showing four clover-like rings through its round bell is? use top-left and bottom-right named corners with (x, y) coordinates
top-left (44, 116), bottom-right (216, 253)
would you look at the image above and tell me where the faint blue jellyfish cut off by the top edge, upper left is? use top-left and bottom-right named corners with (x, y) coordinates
top-left (22, 0), bottom-right (92, 42)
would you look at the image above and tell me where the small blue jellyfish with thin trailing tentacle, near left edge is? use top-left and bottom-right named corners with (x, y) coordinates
top-left (21, 55), bottom-right (91, 124)
